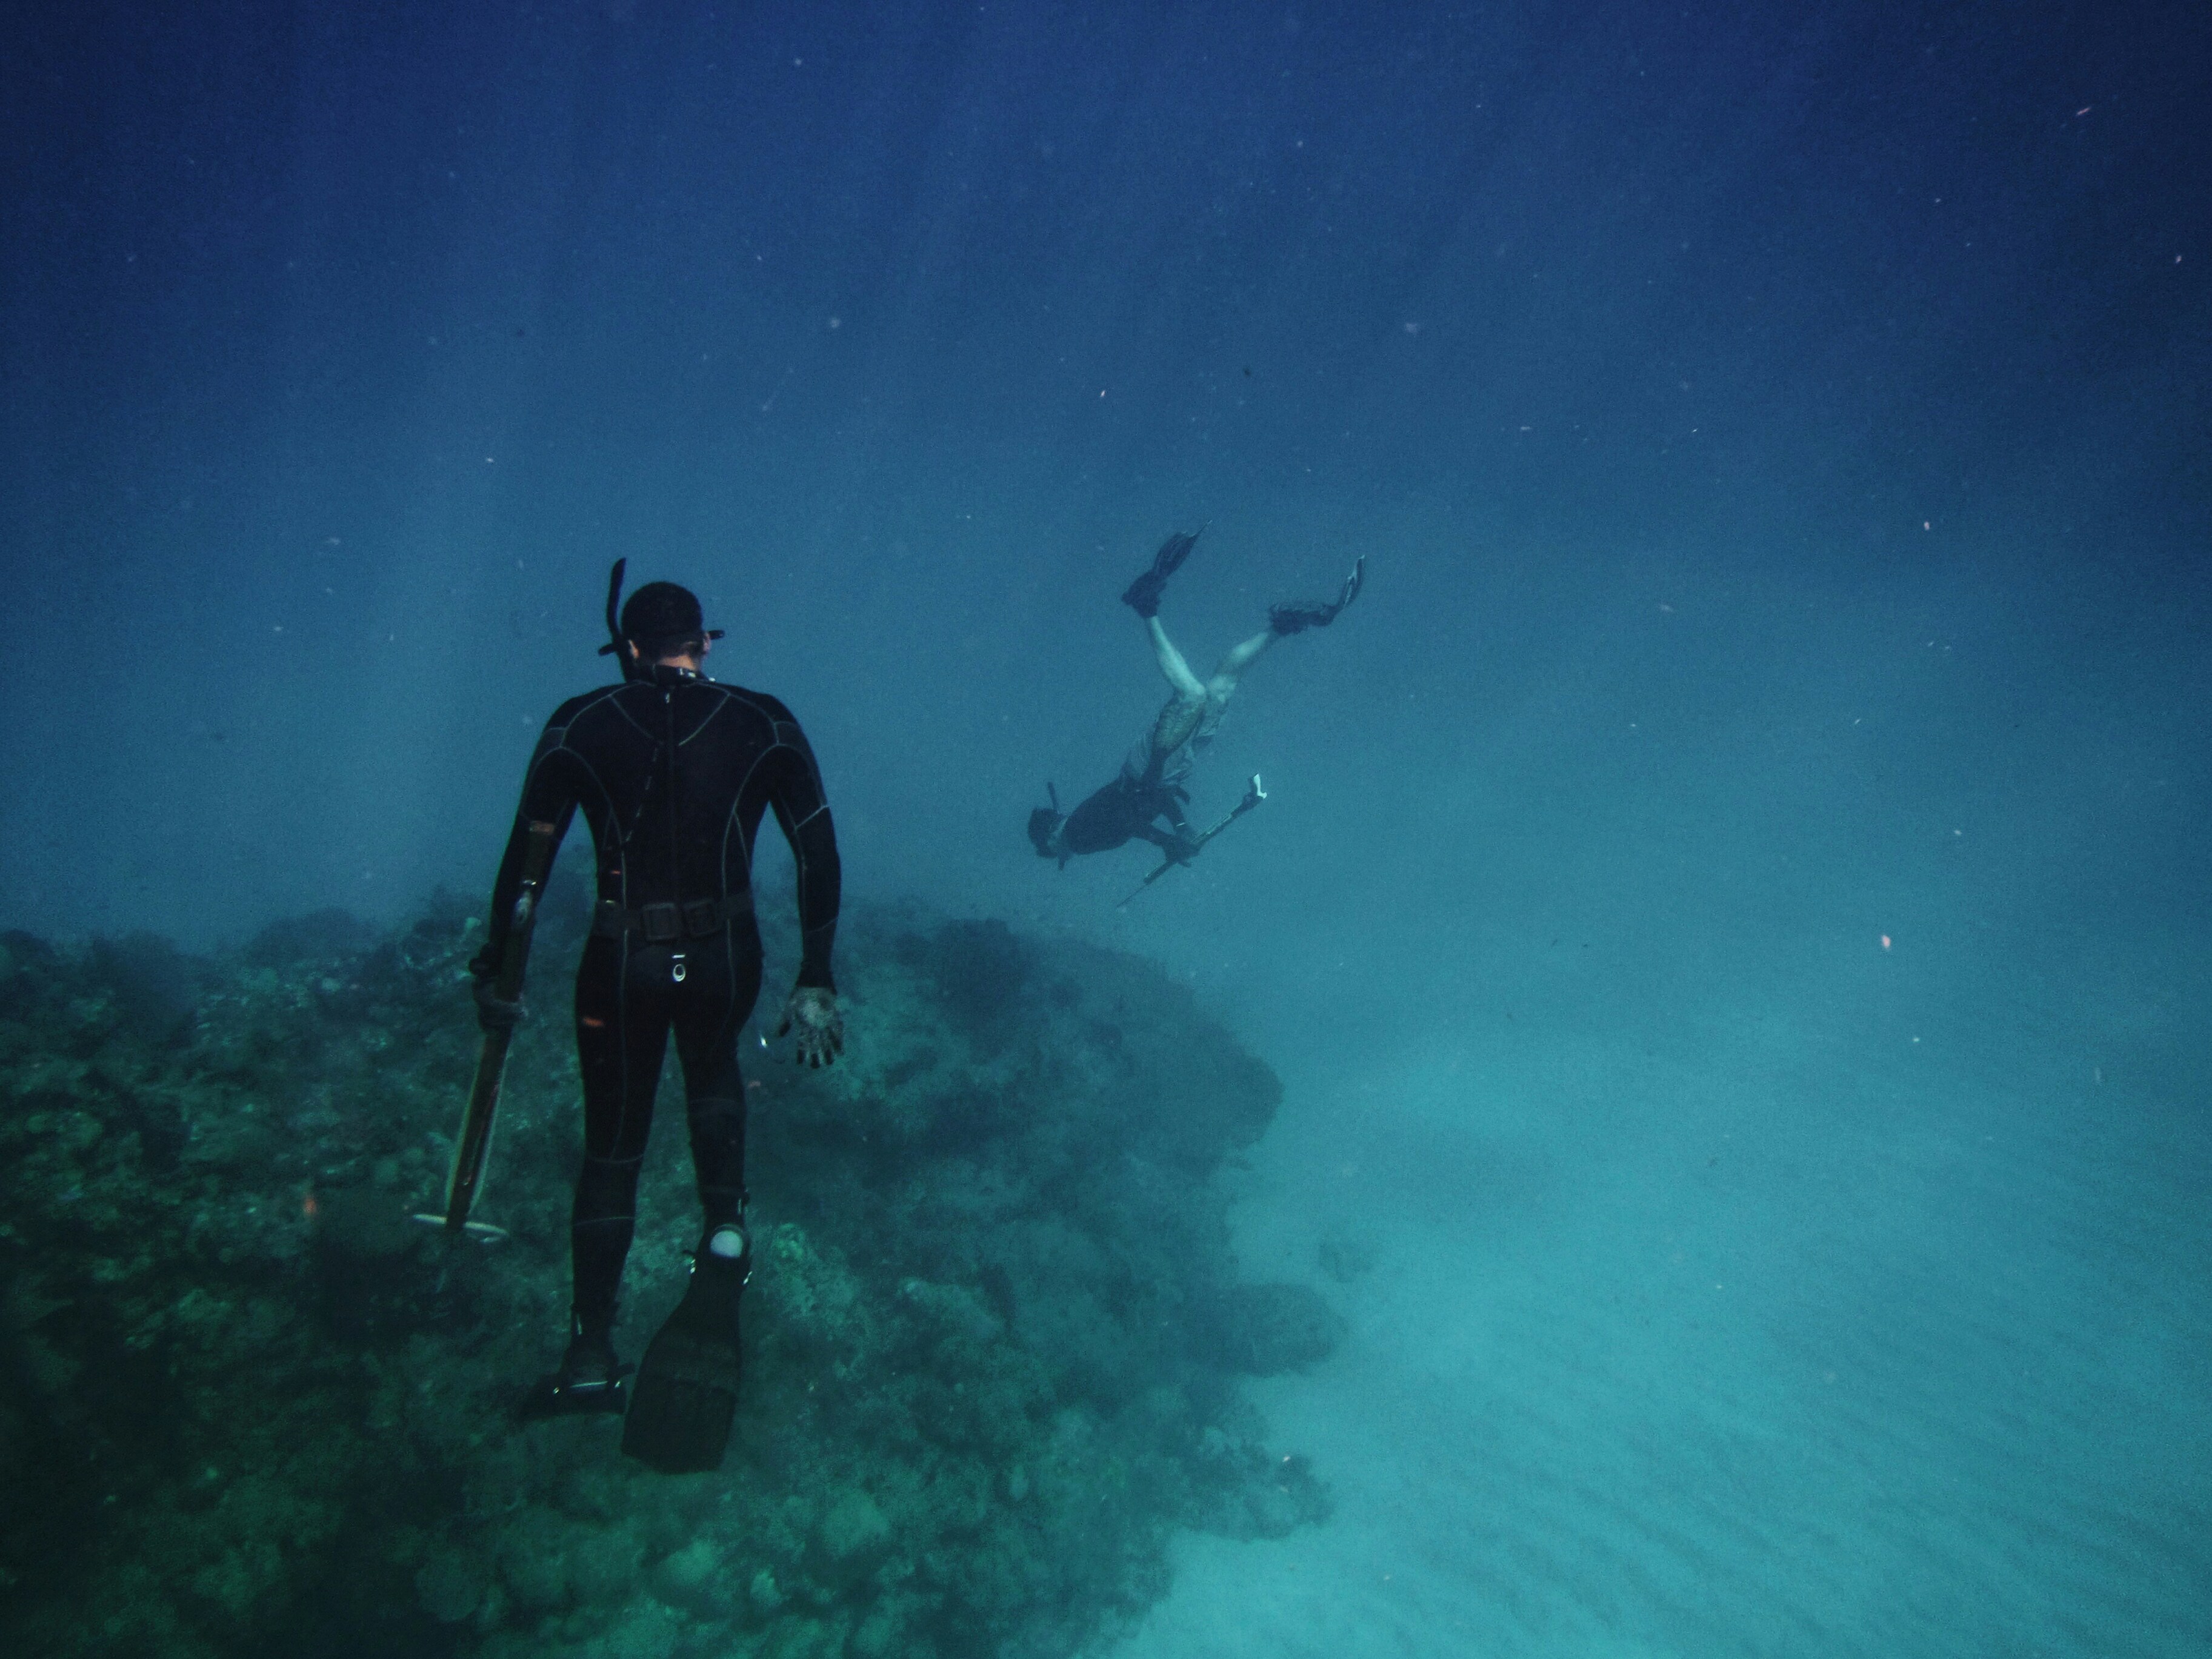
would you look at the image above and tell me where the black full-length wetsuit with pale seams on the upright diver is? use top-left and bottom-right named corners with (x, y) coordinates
top-left (476, 666), bottom-right (838, 1336)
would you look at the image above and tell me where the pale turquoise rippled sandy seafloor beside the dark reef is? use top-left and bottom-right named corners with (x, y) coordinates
top-left (1119, 937), bottom-right (2212, 1659)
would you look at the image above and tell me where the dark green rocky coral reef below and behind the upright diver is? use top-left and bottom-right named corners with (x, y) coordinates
top-left (0, 887), bottom-right (1336, 1659)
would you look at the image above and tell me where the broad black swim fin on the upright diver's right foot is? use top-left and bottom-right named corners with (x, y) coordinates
top-left (622, 1238), bottom-right (752, 1475)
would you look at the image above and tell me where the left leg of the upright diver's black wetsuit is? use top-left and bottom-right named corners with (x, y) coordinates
top-left (568, 938), bottom-right (675, 1336)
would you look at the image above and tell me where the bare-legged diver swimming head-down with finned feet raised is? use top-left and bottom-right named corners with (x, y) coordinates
top-left (1028, 533), bottom-right (1367, 867)
